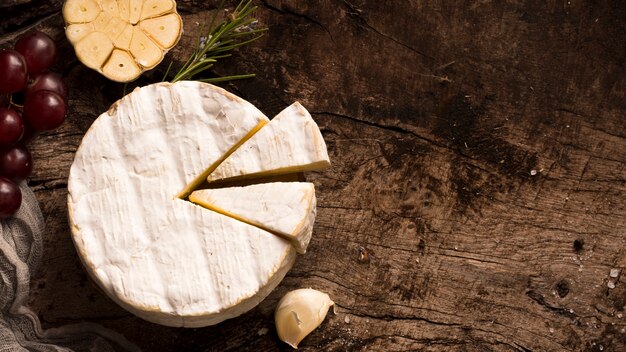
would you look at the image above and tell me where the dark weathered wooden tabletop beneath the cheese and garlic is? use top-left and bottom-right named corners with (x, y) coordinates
top-left (0, 0), bottom-right (626, 351)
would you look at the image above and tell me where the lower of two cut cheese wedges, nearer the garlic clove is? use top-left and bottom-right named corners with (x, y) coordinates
top-left (189, 182), bottom-right (316, 253)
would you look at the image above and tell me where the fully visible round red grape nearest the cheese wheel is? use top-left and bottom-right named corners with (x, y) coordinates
top-left (23, 90), bottom-right (67, 131)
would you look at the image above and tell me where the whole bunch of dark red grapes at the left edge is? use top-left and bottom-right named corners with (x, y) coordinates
top-left (0, 31), bottom-right (67, 218)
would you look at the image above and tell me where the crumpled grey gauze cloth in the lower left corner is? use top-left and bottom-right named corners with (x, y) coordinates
top-left (0, 182), bottom-right (139, 352)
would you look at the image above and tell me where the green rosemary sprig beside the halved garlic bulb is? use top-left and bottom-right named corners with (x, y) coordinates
top-left (168, 0), bottom-right (267, 83)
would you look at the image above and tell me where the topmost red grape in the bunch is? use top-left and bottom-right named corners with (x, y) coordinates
top-left (15, 31), bottom-right (57, 76)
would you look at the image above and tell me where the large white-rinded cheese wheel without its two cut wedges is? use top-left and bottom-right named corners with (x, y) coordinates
top-left (68, 82), bottom-right (296, 327)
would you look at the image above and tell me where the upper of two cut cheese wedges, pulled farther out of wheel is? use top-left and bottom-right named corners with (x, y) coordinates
top-left (207, 102), bottom-right (330, 182)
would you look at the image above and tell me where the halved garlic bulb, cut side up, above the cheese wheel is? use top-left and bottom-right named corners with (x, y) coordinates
top-left (63, 0), bottom-right (183, 82)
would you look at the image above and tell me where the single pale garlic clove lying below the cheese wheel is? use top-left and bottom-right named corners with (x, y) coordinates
top-left (274, 288), bottom-right (335, 348)
